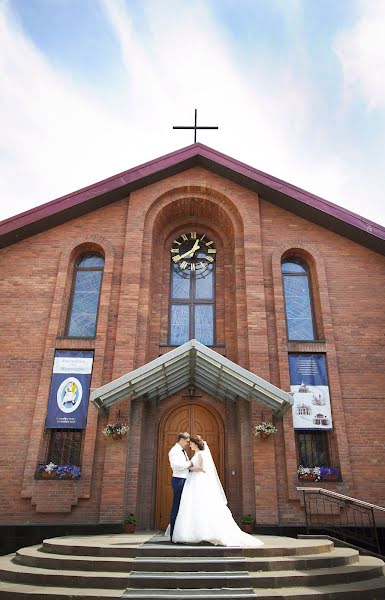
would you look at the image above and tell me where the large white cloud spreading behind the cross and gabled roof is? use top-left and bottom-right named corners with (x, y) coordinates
top-left (0, 0), bottom-right (385, 230)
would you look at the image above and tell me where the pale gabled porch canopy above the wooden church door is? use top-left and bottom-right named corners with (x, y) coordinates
top-left (91, 340), bottom-right (293, 416)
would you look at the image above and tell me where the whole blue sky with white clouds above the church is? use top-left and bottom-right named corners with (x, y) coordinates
top-left (0, 0), bottom-right (385, 226)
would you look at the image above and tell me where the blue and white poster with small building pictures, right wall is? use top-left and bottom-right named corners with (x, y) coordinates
top-left (289, 354), bottom-right (333, 430)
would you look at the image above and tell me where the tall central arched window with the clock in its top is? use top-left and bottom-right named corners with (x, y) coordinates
top-left (169, 232), bottom-right (216, 346)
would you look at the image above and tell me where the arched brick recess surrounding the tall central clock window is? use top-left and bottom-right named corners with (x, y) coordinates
top-left (133, 186), bottom-right (247, 364)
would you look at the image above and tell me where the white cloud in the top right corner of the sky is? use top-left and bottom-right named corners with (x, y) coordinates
top-left (334, 0), bottom-right (385, 108)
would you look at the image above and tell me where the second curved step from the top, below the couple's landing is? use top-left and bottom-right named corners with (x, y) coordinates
top-left (15, 544), bottom-right (359, 572)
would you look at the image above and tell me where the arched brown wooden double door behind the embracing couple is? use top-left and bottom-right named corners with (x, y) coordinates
top-left (155, 403), bottom-right (225, 529)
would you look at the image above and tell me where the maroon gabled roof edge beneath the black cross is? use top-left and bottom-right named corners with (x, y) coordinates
top-left (0, 143), bottom-right (385, 254)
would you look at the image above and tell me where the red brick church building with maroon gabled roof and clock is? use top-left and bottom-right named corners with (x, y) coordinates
top-left (0, 143), bottom-right (385, 530)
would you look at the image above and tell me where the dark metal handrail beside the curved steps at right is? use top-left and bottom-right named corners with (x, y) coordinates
top-left (297, 487), bottom-right (385, 555)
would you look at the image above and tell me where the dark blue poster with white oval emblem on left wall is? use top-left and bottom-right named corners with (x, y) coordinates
top-left (45, 350), bottom-right (94, 429)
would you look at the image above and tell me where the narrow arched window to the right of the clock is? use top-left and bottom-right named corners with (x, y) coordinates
top-left (282, 258), bottom-right (315, 341)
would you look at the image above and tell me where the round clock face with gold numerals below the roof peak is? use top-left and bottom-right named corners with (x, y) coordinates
top-left (171, 231), bottom-right (217, 277)
